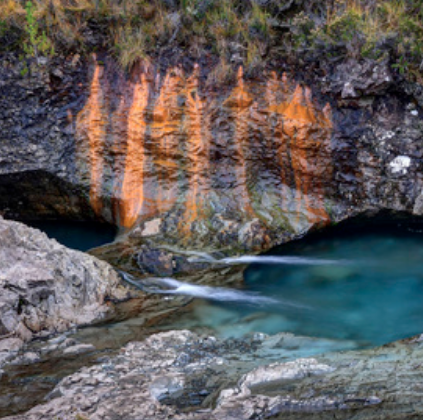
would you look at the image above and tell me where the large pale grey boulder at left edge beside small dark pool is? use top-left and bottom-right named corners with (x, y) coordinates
top-left (0, 217), bottom-right (130, 363)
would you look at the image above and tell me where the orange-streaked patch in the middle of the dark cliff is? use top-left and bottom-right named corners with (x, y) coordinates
top-left (72, 64), bottom-right (332, 233)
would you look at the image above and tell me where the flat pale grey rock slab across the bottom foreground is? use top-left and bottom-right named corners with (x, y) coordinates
top-left (7, 331), bottom-right (423, 420)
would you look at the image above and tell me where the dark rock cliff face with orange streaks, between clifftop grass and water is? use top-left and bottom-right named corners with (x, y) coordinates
top-left (0, 57), bottom-right (423, 265)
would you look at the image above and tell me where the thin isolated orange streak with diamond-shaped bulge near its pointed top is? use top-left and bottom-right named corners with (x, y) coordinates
top-left (225, 67), bottom-right (254, 215)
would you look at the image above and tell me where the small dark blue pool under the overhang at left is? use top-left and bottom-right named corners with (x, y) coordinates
top-left (26, 220), bottom-right (117, 251)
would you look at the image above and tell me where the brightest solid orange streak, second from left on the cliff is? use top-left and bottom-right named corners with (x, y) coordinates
top-left (119, 74), bottom-right (149, 228)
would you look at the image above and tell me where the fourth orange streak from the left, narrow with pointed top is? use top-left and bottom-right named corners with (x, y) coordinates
top-left (184, 66), bottom-right (210, 230)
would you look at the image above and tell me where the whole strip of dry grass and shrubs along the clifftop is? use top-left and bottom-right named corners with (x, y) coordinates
top-left (0, 0), bottom-right (423, 80)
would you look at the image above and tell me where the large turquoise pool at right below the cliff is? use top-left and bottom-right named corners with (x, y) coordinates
top-left (169, 226), bottom-right (423, 347)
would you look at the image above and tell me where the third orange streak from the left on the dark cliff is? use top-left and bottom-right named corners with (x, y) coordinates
top-left (151, 69), bottom-right (184, 213)
